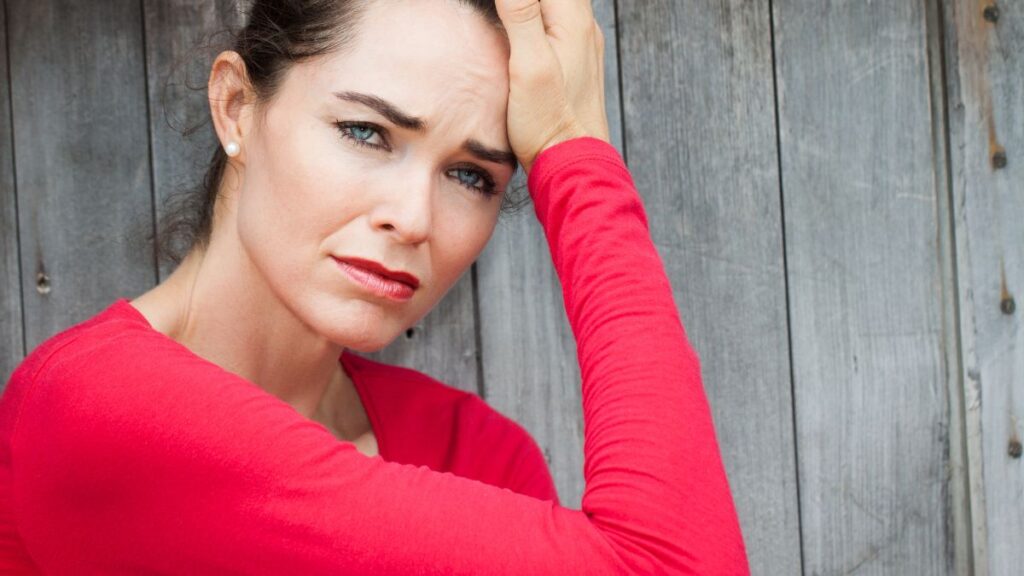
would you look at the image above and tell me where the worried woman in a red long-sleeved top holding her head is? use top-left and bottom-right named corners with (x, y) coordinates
top-left (0, 0), bottom-right (748, 574)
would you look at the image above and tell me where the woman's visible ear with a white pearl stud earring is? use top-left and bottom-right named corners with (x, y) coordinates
top-left (207, 50), bottom-right (253, 165)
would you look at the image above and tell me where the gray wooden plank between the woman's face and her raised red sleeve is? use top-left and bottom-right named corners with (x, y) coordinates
top-left (476, 0), bottom-right (622, 507)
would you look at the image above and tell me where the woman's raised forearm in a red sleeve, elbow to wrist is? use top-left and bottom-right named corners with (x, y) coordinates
top-left (529, 137), bottom-right (749, 574)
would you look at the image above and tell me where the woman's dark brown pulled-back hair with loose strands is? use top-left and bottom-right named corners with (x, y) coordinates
top-left (155, 0), bottom-right (529, 263)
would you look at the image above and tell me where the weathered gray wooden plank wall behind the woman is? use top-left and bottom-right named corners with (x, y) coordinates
top-left (0, 0), bottom-right (1024, 576)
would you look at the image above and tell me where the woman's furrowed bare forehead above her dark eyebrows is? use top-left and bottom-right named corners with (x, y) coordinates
top-left (286, 0), bottom-right (509, 124)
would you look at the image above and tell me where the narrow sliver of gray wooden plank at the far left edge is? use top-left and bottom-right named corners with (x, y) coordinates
top-left (0, 5), bottom-right (25, 393)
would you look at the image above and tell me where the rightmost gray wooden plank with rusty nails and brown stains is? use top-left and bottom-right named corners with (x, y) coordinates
top-left (942, 0), bottom-right (1024, 576)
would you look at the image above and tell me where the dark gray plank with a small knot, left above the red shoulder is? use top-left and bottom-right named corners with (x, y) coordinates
top-left (7, 0), bottom-right (156, 349)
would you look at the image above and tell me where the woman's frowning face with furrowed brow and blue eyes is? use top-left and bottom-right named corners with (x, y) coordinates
top-left (237, 0), bottom-right (515, 352)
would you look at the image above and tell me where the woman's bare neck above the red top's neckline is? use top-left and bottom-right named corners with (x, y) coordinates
top-left (132, 243), bottom-right (351, 420)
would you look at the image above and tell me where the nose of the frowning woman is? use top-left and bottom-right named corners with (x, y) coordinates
top-left (371, 167), bottom-right (434, 245)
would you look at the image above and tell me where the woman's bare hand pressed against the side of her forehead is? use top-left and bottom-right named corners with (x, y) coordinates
top-left (496, 0), bottom-right (611, 173)
